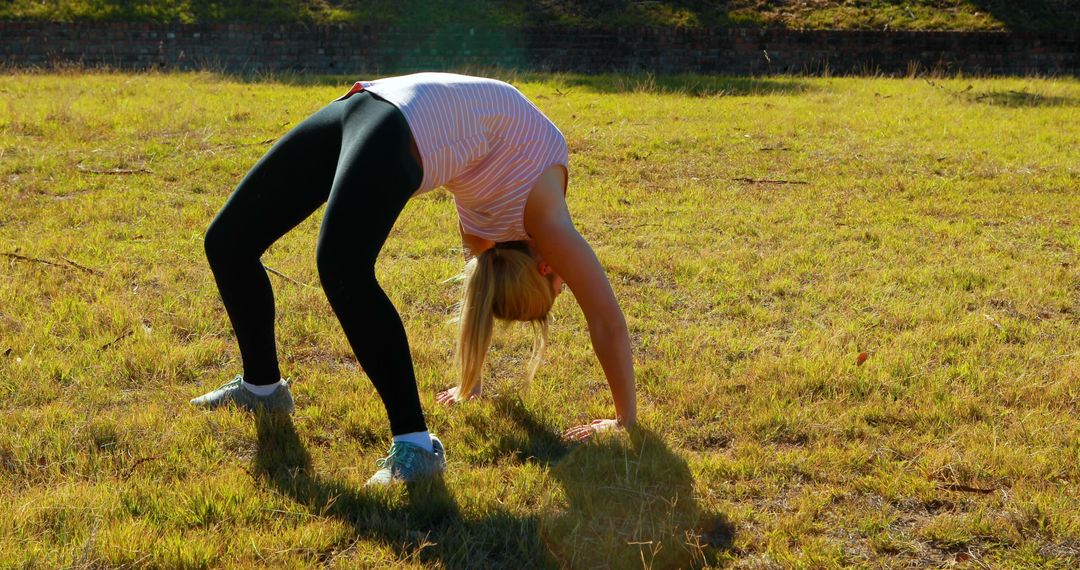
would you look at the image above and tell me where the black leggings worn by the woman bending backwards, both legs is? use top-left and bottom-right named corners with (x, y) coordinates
top-left (205, 92), bottom-right (427, 435)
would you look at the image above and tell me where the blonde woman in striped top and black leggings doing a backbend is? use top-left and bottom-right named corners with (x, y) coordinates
top-left (191, 73), bottom-right (636, 484)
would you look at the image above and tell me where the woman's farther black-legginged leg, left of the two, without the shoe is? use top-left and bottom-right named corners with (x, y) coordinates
top-left (205, 103), bottom-right (343, 384)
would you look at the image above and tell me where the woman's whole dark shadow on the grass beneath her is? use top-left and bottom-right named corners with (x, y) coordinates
top-left (253, 399), bottom-right (733, 568)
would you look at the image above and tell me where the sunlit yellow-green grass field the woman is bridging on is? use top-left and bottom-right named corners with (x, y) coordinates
top-left (0, 72), bottom-right (1080, 569)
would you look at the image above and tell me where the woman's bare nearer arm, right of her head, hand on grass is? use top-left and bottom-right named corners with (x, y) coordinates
top-left (525, 167), bottom-right (637, 438)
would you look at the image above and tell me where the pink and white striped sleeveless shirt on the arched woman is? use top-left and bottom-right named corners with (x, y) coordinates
top-left (340, 73), bottom-right (568, 242)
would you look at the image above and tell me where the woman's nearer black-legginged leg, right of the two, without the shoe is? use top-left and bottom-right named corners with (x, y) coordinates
top-left (316, 93), bottom-right (428, 435)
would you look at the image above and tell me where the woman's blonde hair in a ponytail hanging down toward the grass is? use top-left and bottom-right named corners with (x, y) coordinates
top-left (455, 242), bottom-right (555, 398)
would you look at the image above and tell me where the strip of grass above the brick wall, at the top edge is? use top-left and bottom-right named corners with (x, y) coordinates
top-left (0, 0), bottom-right (1080, 30)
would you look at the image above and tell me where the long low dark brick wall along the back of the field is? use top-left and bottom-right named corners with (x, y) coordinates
top-left (0, 22), bottom-right (1080, 76)
